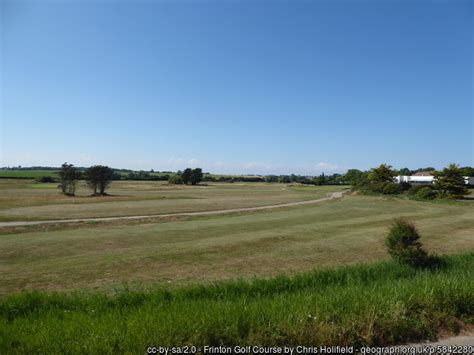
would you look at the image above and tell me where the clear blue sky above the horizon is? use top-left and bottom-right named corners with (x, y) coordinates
top-left (0, 0), bottom-right (474, 175)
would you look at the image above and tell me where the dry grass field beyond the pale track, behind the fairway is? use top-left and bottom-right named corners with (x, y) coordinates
top-left (0, 179), bottom-right (343, 221)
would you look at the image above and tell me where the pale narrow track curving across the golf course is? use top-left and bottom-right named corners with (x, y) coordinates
top-left (0, 191), bottom-right (344, 228)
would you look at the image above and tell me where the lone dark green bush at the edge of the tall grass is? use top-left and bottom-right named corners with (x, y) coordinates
top-left (385, 219), bottom-right (429, 267)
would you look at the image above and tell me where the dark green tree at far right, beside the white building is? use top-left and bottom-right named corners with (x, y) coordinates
top-left (434, 164), bottom-right (469, 198)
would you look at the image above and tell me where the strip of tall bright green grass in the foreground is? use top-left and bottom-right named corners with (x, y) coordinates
top-left (0, 253), bottom-right (474, 354)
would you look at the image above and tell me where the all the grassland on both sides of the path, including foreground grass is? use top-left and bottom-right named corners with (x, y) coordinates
top-left (0, 179), bottom-right (474, 354)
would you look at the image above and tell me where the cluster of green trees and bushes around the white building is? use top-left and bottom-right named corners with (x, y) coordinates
top-left (345, 164), bottom-right (470, 199)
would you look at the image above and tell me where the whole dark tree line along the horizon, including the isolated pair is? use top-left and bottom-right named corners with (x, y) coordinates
top-left (50, 163), bottom-right (474, 199)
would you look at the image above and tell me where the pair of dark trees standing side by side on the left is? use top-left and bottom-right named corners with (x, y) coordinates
top-left (59, 163), bottom-right (114, 196)
